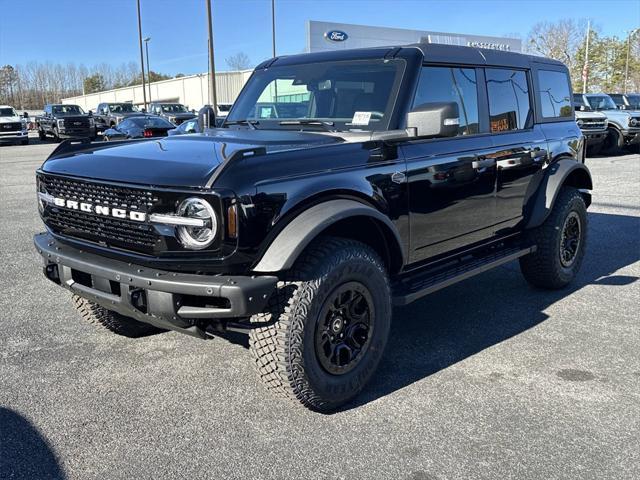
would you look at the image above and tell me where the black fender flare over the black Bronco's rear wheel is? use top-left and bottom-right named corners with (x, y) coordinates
top-left (525, 158), bottom-right (593, 228)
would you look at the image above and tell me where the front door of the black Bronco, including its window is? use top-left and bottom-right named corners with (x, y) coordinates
top-left (402, 65), bottom-right (496, 262)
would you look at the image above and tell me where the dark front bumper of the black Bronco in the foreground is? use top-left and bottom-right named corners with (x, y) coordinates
top-left (33, 233), bottom-right (278, 337)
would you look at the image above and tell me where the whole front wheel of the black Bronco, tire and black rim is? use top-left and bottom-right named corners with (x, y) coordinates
top-left (250, 237), bottom-right (392, 411)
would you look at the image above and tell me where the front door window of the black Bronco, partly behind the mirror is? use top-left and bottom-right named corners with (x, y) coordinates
top-left (413, 67), bottom-right (479, 135)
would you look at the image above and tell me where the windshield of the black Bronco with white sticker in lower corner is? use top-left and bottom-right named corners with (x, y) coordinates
top-left (226, 59), bottom-right (404, 130)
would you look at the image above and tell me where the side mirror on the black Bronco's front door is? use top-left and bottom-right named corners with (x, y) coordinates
top-left (407, 102), bottom-right (460, 137)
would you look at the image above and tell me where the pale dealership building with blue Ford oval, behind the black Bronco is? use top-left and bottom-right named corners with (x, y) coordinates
top-left (62, 21), bottom-right (522, 111)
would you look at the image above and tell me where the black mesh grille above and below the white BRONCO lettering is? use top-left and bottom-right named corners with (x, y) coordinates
top-left (39, 175), bottom-right (161, 253)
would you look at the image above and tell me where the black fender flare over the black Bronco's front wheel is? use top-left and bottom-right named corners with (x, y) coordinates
top-left (253, 199), bottom-right (405, 274)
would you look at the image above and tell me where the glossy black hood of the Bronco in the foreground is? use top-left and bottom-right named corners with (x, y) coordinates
top-left (42, 128), bottom-right (343, 187)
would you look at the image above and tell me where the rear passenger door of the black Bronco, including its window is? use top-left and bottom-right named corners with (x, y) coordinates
top-left (485, 68), bottom-right (548, 235)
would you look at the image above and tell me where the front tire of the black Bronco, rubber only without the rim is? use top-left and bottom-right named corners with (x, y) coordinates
top-left (249, 237), bottom-right (392, 412)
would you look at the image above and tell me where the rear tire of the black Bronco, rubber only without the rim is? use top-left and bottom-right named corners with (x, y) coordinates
top-left (520, 187), bottom-right (587, 289)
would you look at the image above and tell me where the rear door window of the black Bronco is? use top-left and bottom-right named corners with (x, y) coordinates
top-left (485, 68), bottom-right (533, 133)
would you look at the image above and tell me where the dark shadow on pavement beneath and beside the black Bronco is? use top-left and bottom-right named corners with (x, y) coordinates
top-left (345, 213), bottom-right (640, 410)
